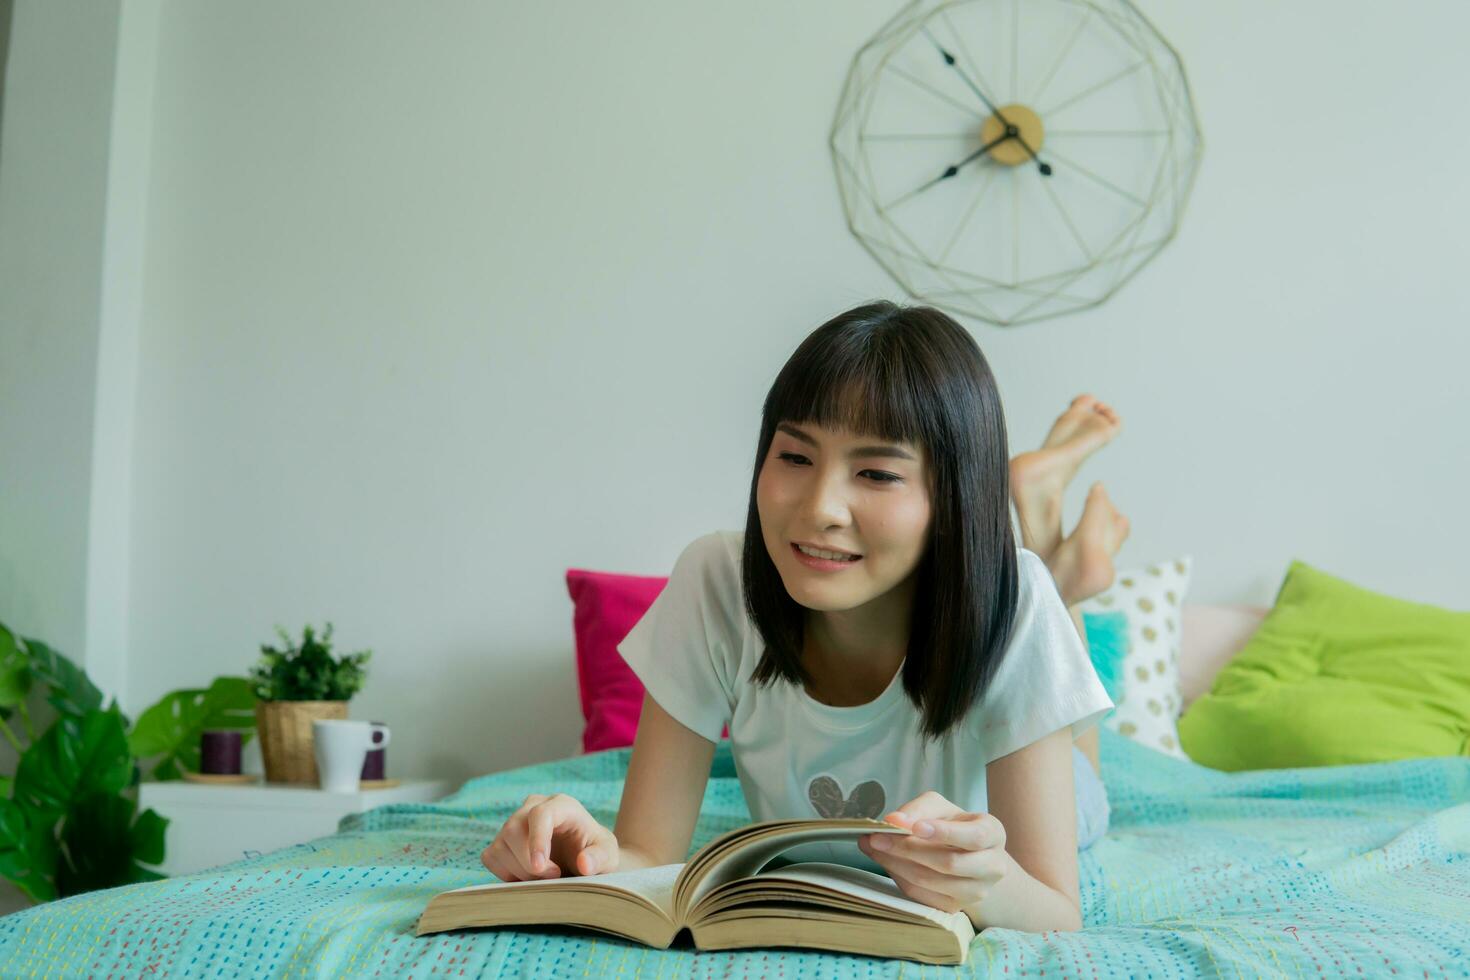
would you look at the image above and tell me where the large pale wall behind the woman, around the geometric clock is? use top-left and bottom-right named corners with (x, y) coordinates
top-left (0, 0), bottom-right (1470, 777)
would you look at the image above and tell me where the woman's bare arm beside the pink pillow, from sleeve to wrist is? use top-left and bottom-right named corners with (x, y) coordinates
top-left (613, 692), bottom-right (717, 871)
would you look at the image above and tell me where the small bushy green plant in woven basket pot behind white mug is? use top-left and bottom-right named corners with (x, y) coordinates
top-left (250, 623), bottom-right (372, 786)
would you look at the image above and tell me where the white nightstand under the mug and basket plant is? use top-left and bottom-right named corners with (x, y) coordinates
top-left (138, 779), bottom-right (451, 874)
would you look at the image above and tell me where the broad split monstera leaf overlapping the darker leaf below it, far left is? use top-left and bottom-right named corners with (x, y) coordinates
top-left (15, 707), bottom-right (134, 817)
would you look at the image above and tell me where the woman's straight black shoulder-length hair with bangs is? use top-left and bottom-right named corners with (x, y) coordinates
top-left (741, 301), bottom-right (1019, 739)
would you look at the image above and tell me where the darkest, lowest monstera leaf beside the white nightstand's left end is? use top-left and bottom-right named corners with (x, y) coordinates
top-left (56, 793), bottom-right (168, 898)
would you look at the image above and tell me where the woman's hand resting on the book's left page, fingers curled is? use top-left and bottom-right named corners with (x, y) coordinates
top-left (479, 793), bottom-right (617, 882)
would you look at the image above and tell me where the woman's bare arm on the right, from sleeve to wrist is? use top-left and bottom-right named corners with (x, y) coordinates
top-left (966, 726), bottom-right (1082, 933)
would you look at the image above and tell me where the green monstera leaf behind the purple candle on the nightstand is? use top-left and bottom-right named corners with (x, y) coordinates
top-left (128, 677), bottom-right (256, 780)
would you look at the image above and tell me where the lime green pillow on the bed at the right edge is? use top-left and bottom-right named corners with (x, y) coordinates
top-left (1179, 561), bottom-right (1470, 770)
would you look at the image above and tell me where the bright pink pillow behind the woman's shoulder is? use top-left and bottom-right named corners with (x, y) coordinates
top-left (566, 569), bottom-right (728, 752)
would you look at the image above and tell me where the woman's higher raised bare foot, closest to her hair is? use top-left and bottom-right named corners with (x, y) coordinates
top-left (1010, 395), bottom-right (1123, 560)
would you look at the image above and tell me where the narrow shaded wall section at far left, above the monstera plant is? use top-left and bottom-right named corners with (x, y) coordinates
top-left (0, 0), bottom-right (118, 661)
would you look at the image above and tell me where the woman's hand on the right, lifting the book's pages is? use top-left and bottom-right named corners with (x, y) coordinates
top-left (857, 790), bottom-right (1011, 912)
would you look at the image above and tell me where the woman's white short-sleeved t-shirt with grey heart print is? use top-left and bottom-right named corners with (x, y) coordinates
top-left (617, 530), bottom-right (1113, 871)
